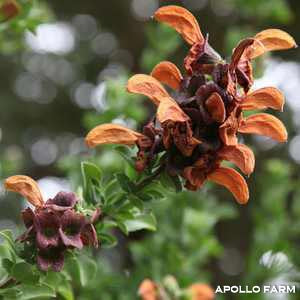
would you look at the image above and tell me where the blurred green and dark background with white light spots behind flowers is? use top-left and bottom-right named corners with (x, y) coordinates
top-left (0, 0), bottom-right (300, 300)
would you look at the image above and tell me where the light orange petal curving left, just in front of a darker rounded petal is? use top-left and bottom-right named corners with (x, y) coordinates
top-left (127, 74), bottom-right (170, 105)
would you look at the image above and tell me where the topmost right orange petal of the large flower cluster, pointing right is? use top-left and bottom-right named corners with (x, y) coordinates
top-left (250, 29), bottom-right (297, 58)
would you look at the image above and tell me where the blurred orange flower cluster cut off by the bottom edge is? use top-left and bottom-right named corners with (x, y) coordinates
top-left (138, 276), bottom-right (215, 300)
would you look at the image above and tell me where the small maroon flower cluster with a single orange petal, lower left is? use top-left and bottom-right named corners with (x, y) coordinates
top-left (5, 175), bottom-right (100, 271)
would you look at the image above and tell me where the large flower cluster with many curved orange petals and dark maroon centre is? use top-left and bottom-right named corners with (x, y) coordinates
top-left (86, 6), bottom-right (296, 204)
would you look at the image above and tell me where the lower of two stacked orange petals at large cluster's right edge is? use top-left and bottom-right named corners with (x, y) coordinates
top-left (239, 113), bottom-right (288, 143)
